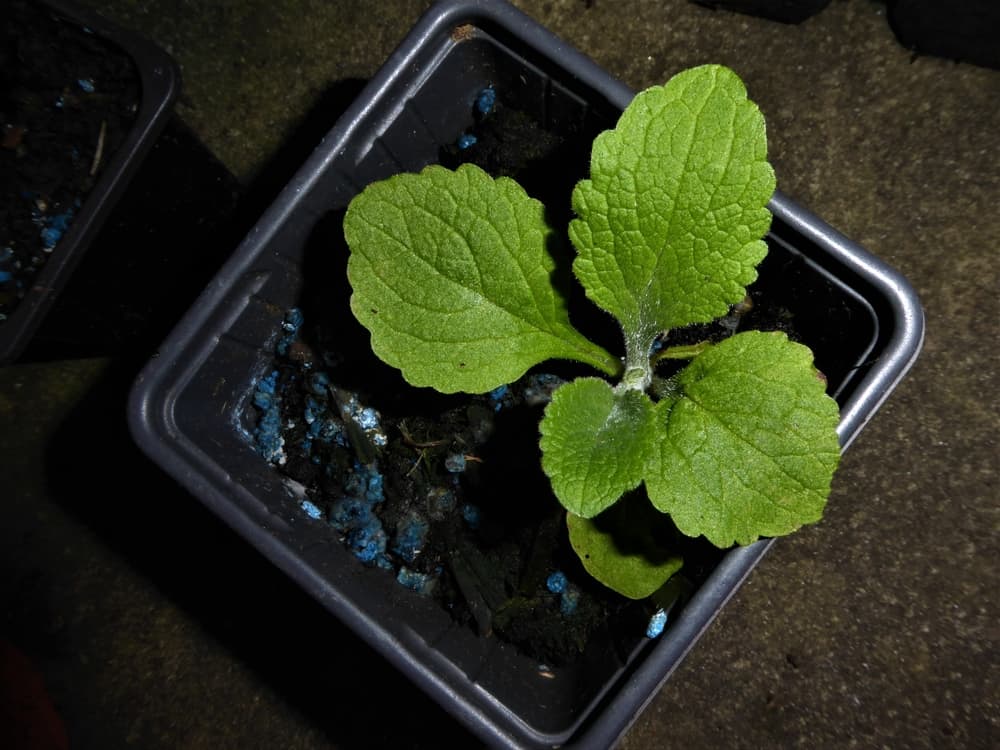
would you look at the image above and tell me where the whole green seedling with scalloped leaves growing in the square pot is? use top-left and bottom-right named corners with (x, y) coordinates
top-left (344, 65), bottom-right (840, 598)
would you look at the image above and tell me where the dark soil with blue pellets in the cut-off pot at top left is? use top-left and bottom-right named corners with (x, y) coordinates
top-left (0, 0), bottom-right (140, 324)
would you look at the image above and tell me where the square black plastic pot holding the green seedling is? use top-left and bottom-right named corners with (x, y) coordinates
top-left (129, 2), bottom-right (923, 748)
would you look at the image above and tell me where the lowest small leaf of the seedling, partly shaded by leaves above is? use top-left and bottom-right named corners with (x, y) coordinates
top-left (566, 513), bottom-right (684, 599)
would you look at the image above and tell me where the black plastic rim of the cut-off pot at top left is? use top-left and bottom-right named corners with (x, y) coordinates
top-left (0, 0), bottom-right (180, 364)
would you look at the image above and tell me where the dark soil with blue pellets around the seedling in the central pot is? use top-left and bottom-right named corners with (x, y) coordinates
top-left (242, 85), bottom-right (844, 665)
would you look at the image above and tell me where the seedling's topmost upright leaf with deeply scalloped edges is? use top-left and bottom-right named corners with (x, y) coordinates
top-left (569, 65), bottom-right (775, 346)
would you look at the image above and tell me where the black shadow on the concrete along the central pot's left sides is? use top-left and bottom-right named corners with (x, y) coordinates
top-left (32, 80), bottom-right (488, 748)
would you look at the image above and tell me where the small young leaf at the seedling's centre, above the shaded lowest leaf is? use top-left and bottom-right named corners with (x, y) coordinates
top-left (541, 378), bottom-right (655, 518)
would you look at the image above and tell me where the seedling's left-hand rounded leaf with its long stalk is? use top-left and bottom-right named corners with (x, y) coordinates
top-left (344, 164), bottom-right (618, 393)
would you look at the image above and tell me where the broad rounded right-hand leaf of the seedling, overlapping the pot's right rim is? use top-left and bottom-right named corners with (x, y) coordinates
top-left (645, 331), bottom-right (840, 547)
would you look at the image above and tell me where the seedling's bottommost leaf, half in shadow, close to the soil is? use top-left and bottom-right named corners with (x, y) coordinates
top-left (566, 497), bottom-right (684, 599)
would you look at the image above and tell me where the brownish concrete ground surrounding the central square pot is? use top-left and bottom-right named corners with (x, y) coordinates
top-left (0, 0), bottom-right (1000, 750)
